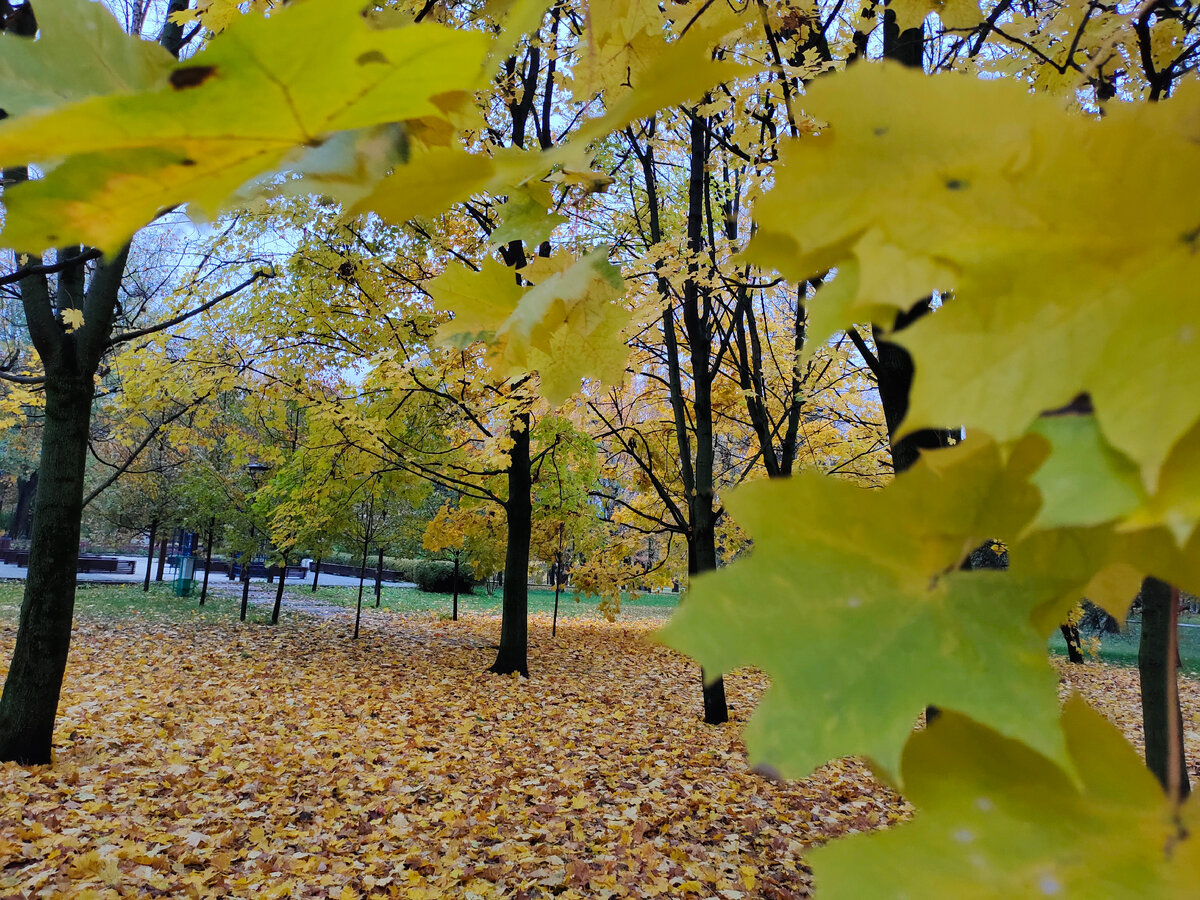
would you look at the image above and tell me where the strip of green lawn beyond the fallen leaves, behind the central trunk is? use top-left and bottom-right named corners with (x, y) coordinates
top-left (284, 581), bottom-right (679, 618)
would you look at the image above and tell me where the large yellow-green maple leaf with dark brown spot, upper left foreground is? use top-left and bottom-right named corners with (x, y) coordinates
top-left (0, 0), bottom-right (490, 251)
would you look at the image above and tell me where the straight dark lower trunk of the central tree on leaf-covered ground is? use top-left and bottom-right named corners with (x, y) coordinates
top-left (488, 413), bottom-right (533, 678)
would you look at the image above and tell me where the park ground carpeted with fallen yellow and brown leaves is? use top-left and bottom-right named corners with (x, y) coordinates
top-left (0, 594), bottom-right (1200, 899)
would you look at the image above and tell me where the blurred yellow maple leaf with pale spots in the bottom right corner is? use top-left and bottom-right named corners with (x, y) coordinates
top-left (811, 696), bottom-right (1200, 900)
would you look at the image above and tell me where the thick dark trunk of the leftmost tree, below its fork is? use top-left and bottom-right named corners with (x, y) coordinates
top-left (0, 372), bottom-right (94, 766)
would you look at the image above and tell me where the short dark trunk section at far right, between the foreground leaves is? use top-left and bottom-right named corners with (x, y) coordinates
top-left (1138, 578), bottom-right (1192, 798)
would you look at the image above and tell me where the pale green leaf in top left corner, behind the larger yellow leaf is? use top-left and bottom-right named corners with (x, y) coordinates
top-left (0, 0), bottom-right (175, 116)
